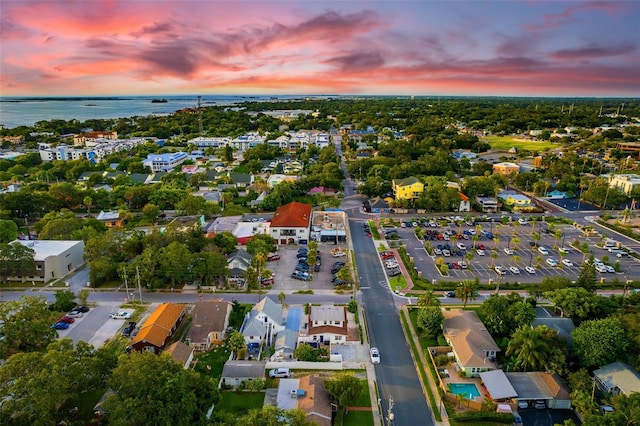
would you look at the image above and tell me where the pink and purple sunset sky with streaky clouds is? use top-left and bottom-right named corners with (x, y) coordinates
top-left (0, 0), bottom-right (640, 96)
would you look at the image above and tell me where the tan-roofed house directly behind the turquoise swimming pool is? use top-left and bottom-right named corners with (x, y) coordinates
top-left (442, 309), bottom-right (500, 377)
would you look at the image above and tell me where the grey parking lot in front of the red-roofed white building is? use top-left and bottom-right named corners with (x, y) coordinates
top-left (265, 243), bottom-right (350, 291)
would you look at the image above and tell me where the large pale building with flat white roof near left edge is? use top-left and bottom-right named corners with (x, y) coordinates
top-left (9, 240), bottom-right (84, 282)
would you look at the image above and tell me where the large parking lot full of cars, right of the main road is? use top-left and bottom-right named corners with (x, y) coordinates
top-left (384, 216), bottom-right (640, 283)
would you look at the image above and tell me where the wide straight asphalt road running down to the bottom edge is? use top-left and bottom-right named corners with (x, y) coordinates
top-left (349, 219), bottom-right (433, 425)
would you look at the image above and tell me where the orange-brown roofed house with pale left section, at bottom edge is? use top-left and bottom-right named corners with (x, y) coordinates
top-left (276, 376), bottom-right (333, 426)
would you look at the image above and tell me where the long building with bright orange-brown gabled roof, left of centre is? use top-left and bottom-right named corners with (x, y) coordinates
top-left (131, 303), bottom-right (185, 354)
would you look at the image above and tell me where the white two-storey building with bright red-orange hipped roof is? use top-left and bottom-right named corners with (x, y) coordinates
top-left (270, 201), bottom-right (311, 244)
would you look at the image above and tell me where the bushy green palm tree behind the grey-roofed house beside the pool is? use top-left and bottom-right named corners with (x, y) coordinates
top-left (506, 327), bottom-right (553, 371)
